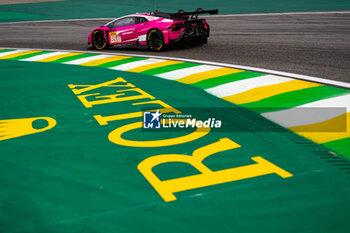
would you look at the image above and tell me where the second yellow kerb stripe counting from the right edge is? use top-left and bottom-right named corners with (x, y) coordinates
top-left (223, 80), bottom-right (322, 104)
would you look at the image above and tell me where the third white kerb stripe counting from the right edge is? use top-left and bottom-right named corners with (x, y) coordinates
top-left (156, 65), bottom-right (222, 80)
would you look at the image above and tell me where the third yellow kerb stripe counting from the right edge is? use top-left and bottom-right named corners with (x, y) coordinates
top-left (176, 68), bottom-right (243, 84)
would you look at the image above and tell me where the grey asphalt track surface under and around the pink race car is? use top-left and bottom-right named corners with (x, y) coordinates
top-left (0, 13), bottom-right (350, 82)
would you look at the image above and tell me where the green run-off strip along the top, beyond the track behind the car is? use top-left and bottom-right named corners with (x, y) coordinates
top-left (0, 0), bottom-right (350, 22)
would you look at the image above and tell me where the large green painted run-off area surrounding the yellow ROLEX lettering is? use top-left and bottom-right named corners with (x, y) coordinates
top-left (0, 61), bottom-right (350, 233)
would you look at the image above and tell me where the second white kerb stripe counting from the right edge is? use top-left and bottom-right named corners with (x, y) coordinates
top-left (206, 75), bottom-right (294, 98)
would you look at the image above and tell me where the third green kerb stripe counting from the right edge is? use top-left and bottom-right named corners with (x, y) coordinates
top-left (191, 71), bottom-right (266, 89)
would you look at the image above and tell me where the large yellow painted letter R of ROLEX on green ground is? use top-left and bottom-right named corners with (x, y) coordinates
top-left (138, 138), bottom-right (293, 202)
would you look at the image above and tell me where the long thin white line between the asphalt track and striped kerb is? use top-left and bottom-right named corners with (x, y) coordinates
top-left (1, 47), bottom-right (350, 89)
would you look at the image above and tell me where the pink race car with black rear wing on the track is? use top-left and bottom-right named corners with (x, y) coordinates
top-left (89, 8), bottom-right (218, 51)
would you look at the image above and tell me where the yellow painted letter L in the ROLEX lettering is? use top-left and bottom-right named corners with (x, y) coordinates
top-left (94, 100), bottom-right (181, 125)
